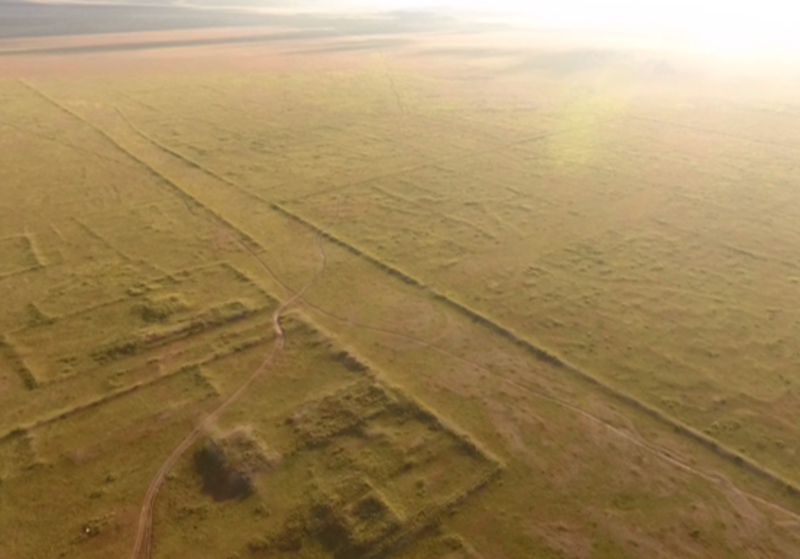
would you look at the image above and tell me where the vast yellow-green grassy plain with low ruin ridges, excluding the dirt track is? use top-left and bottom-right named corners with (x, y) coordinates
top-left (0, 25), bottom-right (800, 559)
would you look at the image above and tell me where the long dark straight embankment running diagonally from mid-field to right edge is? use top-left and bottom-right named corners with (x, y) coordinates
top-left (271, 203), bottom-right (800, 496)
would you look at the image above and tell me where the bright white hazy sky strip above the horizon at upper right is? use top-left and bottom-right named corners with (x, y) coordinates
top-left (353, 0), bottom-right (800, 57)
